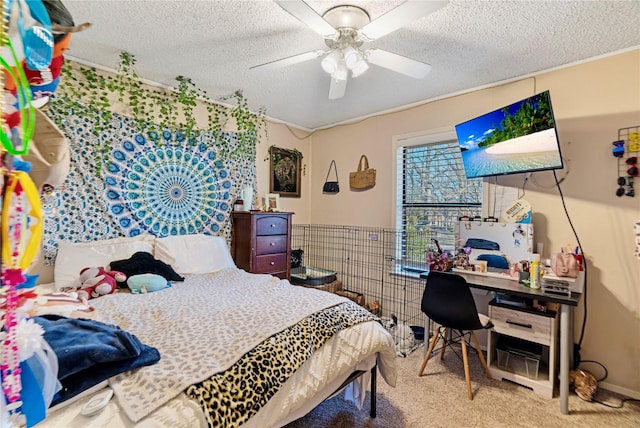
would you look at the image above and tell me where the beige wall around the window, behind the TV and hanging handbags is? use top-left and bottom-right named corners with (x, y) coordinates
top-left (308, 50), bottom-right (640, 397)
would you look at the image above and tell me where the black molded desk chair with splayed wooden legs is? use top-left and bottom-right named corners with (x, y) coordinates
top-left (418, 271), bottom-right (493, 400)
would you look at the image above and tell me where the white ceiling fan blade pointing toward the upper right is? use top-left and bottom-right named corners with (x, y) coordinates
top-left (359, 0), bottom-right (449, 41)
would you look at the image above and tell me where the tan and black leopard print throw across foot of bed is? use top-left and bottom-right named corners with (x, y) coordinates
top-left (185, 302), bottom-right (377, 428)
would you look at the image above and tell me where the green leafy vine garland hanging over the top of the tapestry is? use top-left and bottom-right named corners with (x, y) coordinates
top-left (52, 52), bottom-right (268, 176)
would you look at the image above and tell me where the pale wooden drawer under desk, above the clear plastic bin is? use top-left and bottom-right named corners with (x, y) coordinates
top-left (489, 305), bottom-right (553, 346)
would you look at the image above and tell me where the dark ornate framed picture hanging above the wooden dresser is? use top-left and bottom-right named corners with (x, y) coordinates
top-left (269, 146), bottom-right (302, 198)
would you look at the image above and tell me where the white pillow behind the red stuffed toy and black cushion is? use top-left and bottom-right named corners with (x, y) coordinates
top-left (54, 235), bottom-right (155, 290)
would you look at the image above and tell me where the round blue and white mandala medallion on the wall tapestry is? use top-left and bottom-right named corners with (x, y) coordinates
top-left (105, 132), bottom-right (231, 236)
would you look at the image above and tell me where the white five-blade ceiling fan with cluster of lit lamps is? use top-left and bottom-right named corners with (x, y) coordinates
top-left (251, 0), bottom-right (449, 100)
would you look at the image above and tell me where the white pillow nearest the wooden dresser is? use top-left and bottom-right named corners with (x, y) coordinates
top-left (155, 234), bottom-right (236, 275)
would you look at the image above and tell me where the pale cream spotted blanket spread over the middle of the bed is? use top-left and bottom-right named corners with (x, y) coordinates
top-left (92, 268), bottom-right (360, 422)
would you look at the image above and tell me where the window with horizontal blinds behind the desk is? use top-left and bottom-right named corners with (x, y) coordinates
top-left (396, 132), bottom-right (482, 266)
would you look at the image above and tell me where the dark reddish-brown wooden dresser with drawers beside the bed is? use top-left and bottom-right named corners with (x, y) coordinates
top-left (231, 211), bottom-right (293, 279)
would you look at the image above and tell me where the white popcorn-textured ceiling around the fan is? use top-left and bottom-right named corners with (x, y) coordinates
top-left (64, 0), bottom-right (640, 129)
